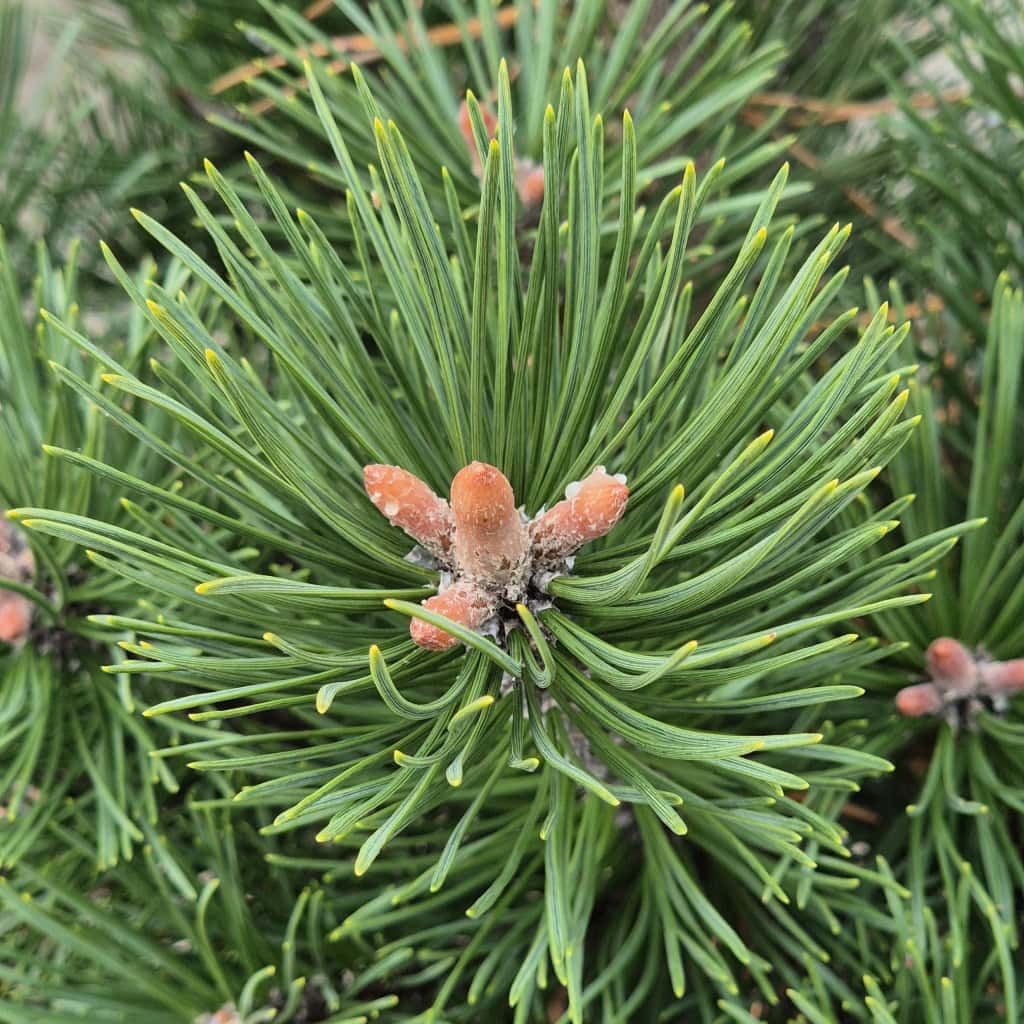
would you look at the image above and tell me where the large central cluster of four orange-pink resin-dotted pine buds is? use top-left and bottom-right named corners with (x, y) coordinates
top-left (362, 462), bottom-right (630, 650)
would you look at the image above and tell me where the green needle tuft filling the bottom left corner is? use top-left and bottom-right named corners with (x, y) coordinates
top-left (0, 797), bottom-right (399, 1024)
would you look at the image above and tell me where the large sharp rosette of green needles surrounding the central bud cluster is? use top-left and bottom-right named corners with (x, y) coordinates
top-left (13, 59), bottom-right (966, 1020)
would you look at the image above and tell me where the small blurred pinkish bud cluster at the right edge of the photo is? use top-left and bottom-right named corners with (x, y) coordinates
top-left (896, 637), bottom-right (1024, 718)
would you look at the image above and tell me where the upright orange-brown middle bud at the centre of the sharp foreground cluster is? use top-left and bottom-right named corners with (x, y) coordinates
top-left (452, 462), bottom-right (526, 585)
